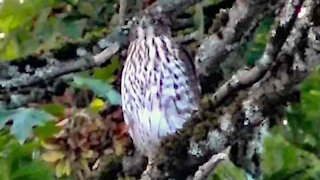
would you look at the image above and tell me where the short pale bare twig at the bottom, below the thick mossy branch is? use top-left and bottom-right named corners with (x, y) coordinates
top-left (193, 148), bottom-right (230, 180)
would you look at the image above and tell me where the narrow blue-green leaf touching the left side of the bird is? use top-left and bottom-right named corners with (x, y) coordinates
top-left (73, 76), bottom-right (121, 105)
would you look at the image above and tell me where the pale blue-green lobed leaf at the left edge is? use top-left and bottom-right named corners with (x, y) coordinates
top-left (0, 108), bottom-right (54, 143)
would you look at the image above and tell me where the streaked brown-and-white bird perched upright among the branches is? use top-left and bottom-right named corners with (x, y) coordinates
top-left (121, 16), bottom-right (200, 163)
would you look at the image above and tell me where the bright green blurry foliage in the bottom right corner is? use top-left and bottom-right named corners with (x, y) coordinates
top-left (261, 134), bottom-right (320, 180)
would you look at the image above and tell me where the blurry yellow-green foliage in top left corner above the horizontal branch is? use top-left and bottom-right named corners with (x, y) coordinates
top-left (0, 0), bottom-right (116, 60)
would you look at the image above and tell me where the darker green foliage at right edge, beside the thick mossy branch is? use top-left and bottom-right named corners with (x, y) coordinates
top-left (286, 69), bottom-right (320, 154)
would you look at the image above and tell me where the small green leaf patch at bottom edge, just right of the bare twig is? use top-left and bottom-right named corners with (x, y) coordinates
top-left (210, 161), bottom-right (247, 180)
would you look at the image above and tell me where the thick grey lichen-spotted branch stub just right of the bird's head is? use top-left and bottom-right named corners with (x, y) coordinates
top-left (195, 0), bottom-right (278, 76)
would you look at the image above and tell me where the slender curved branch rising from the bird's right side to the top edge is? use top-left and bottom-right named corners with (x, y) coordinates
top-left (205, 0), bottom-right (303, 108)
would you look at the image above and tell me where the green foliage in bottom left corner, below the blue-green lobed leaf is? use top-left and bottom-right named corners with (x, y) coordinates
top-left (0, 130), bottom-right (53, 180)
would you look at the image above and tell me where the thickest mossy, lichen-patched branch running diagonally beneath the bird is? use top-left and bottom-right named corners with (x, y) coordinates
top-left (138, 0), bottom-right (320, 179)
